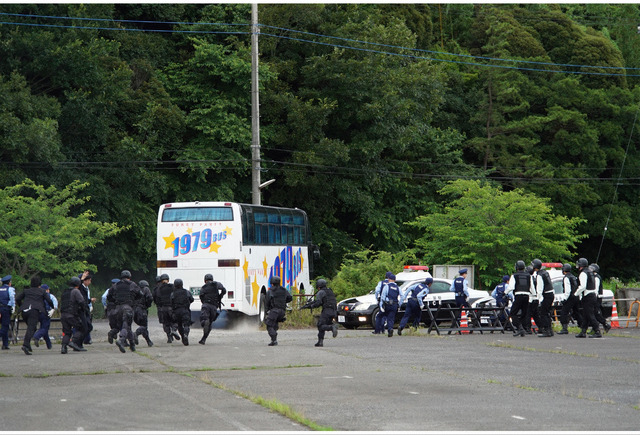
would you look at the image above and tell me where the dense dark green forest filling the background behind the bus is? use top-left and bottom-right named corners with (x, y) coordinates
top-left (0, 3), bottom-right (640, 286)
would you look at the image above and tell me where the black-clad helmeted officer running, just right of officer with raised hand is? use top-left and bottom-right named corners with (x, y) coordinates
top-left (107, 270), bottom-right (142, 353)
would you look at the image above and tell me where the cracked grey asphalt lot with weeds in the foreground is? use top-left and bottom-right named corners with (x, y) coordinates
top-left (0, 319), bottom-right (640, 432)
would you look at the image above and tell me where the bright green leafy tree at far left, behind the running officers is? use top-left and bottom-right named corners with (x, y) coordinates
top-left (0, 179), bottom-right (123, 288)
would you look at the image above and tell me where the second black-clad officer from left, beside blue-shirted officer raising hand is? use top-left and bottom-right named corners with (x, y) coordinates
top-left (60, 276), bottom-right (87, 354)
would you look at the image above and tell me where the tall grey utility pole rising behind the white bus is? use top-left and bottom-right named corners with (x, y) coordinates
top-left (251, 3), bottom-right (262, 205)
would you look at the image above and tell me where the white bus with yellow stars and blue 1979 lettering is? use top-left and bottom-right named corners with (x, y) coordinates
top-left (157, 201), bottom-right (318, 323)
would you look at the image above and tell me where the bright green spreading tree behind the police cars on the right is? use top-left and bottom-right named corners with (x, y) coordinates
top-left (409, 180), bottom-right (583, 286)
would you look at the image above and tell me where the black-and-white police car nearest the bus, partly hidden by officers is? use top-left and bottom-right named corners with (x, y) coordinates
top-left (338, 266), bottom-right (495, 329)
